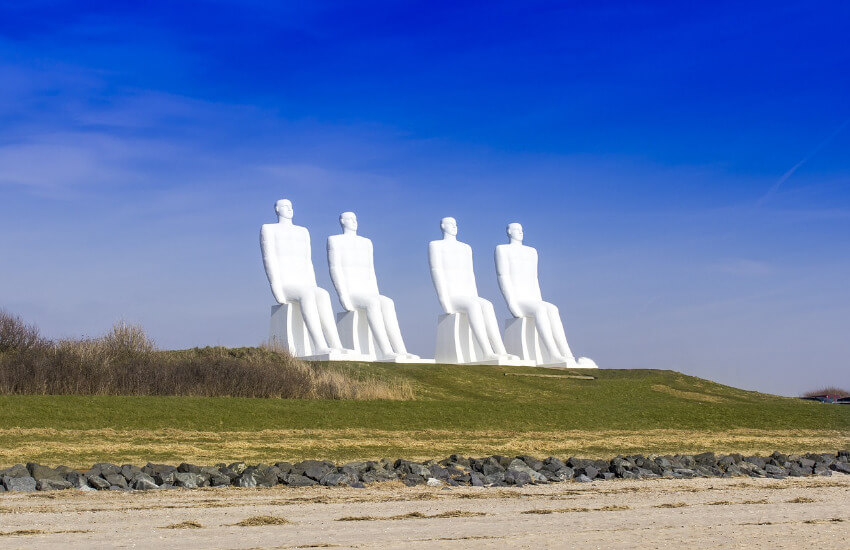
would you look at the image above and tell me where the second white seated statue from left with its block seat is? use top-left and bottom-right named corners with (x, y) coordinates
top-left (328, 212), bottom-right (423, 363)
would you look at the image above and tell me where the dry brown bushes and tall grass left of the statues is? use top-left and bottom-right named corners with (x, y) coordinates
top-left (0, 311), bottom-right (413, 400)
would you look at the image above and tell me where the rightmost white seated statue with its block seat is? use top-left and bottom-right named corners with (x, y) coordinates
top-left (496, 223), bottom-right (596, 368)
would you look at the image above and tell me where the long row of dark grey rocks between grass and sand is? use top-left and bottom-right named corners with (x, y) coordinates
top-left (0, 451), bottom-right (850, 492)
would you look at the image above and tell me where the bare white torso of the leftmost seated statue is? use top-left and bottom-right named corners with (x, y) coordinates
top-left (262, 223), bottom-right (317, 287)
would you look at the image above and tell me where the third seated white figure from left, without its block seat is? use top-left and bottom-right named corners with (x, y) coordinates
top-left (428, 218), bottom-right (517, 363)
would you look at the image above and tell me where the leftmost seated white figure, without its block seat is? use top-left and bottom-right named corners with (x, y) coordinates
top-left (260, 199), bottom-right (347, 358)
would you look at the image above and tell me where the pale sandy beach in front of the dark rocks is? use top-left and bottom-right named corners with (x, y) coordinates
top-left (0, 476), bottom-right (850, 550)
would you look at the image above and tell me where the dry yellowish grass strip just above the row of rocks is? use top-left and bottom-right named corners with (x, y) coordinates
top-left (0, 428), bottom-right (850, 468)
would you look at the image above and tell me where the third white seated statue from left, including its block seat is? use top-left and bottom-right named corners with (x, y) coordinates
top-left (428, 218), bottom-right (533, 365)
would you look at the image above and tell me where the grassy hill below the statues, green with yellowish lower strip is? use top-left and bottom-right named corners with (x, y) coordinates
top-left (0, 358), bottom-right (850, 466)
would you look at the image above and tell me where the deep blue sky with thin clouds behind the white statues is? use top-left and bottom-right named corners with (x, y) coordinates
top-left (0, 1), bottom-right (850, 395)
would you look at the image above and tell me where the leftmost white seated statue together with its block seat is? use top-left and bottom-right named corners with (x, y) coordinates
top-left (260, 199), bottom-right (352, 361)
